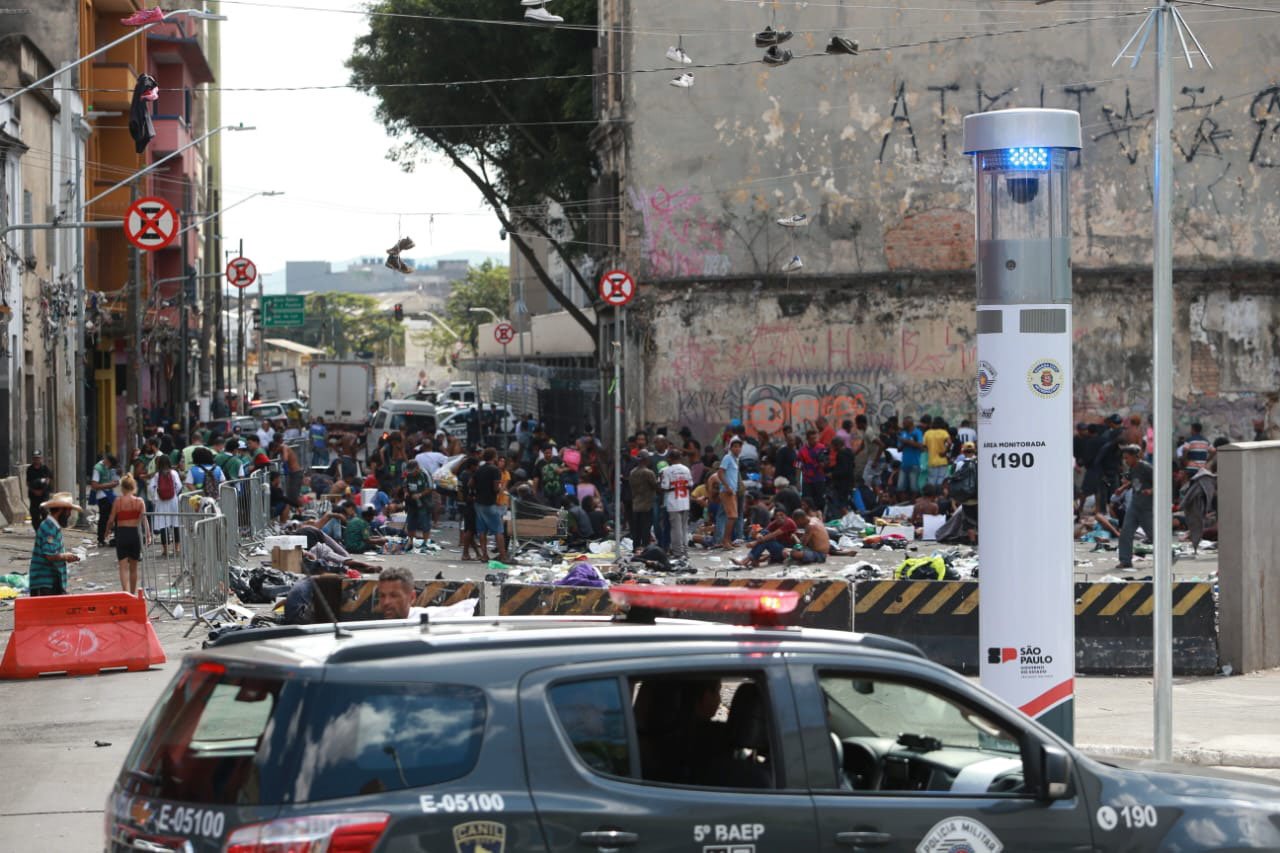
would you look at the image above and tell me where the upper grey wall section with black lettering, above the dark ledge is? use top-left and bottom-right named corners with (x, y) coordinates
top-left (620, 0), bottom-right (1280, 279)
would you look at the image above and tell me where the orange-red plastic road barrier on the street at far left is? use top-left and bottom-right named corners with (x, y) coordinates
top-left (0, 592), bottom-right (165, 679)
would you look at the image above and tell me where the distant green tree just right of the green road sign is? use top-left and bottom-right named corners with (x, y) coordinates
top-left (296, 292), bottom-right (404, 361)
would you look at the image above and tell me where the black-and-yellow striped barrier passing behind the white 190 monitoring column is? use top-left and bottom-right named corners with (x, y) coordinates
top-left (854, 580), bottom-right (1217, 675)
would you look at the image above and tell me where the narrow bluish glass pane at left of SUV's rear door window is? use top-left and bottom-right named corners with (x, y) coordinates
top-left (550, 679), bottom-right (631, 776)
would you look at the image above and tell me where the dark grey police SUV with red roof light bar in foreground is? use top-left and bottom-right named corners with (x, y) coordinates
top-left (105, 587), bottom-right (1280, 853)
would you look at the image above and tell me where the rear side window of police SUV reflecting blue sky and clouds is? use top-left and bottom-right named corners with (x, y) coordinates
top-left (292, 683), bottom-right (485, 802)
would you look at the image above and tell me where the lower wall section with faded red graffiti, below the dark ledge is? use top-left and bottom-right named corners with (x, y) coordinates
top-left (632, 270), bottom-right (1280, 438)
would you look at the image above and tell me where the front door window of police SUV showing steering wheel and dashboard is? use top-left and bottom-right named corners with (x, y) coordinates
top-left (819, 672), bottom-right (1024, 795)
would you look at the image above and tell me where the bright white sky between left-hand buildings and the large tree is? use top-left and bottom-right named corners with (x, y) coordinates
top-left (213, 0), bottom-right (507, 292)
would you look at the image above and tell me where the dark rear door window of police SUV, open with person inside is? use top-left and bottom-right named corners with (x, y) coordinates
top-left (630, 672), bottom-right (778, 789)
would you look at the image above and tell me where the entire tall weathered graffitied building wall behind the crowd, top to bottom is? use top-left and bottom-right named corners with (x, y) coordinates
top-left (591, 0), bottom-right (1280, 437)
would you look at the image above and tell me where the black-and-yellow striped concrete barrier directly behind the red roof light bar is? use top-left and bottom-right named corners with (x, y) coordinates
top-left (498, 578), bottom-right (854, 631)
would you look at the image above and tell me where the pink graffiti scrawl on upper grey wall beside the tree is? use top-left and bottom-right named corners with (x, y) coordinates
top-left (630, 186), bottom-right (730, 277)
